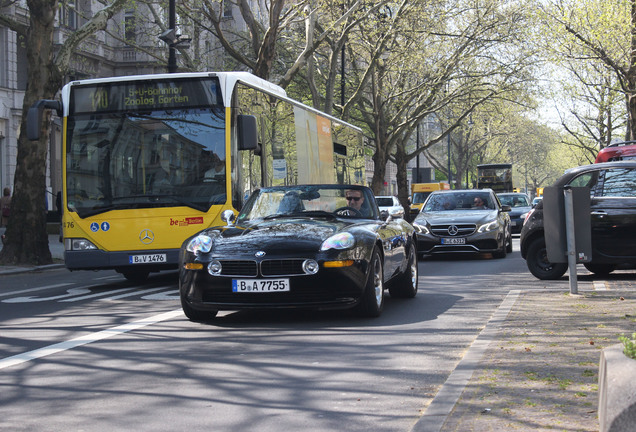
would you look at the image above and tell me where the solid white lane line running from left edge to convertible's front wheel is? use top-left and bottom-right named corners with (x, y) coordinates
top-left (0, 309), bottom-right (183, 370)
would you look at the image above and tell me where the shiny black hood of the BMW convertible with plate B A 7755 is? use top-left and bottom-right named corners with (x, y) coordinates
top-left (202, 218), bottom-right (352, 255)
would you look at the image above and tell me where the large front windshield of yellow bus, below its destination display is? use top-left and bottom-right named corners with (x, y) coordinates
top-left (66, 81), bottom-right (226, 218)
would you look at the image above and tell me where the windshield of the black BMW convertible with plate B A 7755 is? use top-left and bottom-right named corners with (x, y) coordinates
top-left (237, 185), bottom-right (377, 223)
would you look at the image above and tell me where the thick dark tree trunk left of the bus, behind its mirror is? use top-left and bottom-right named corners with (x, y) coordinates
top-left (0, 0), bottom-right (58, 265)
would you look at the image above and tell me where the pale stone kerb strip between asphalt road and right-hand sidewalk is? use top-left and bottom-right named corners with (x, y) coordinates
top-left (411, 290), bottom-right (521, 432)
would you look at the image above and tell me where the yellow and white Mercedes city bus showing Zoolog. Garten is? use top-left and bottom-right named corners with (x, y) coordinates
top-left (27, 72), bottom-right (365, 281)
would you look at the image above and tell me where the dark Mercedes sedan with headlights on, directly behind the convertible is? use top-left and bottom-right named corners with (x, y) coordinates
top-left (413, 189), bottom-right (512, 258)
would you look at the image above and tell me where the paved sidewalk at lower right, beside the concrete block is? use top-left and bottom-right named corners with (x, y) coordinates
top-left (422, 271), bottom-right (636, 432)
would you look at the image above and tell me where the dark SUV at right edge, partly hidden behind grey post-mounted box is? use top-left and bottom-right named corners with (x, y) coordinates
top-left (521, 161), bottom-right (636, 279)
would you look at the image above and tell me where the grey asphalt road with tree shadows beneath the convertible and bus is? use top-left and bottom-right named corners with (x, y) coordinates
top-left (0, 239), bottom-right (536, 432)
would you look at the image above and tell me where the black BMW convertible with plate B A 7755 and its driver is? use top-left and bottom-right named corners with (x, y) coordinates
top-left (179, 185), bottom-right (417, 321)
